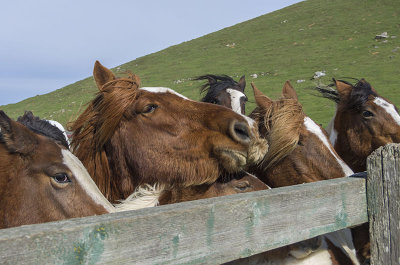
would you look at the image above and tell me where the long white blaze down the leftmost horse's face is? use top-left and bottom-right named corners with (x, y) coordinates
top-left (61, 149), bottom-right (115, 213)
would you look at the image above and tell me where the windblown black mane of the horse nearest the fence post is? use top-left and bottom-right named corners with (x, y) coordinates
top-left (314, 78), bottom-right (378, 110)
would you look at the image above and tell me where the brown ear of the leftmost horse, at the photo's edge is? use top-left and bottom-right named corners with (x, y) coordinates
top-left (0, 110), bottom-right (38, 155)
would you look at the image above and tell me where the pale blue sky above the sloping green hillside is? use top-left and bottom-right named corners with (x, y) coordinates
top-left (0, 0), bottom-right (300, 105)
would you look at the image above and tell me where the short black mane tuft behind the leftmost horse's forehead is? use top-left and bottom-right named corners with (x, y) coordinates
top-left (17, 111), bottom-right (69, 149)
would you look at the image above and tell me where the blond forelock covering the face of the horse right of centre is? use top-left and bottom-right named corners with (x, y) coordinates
top-left (250, 98), bottom-right (305, 168)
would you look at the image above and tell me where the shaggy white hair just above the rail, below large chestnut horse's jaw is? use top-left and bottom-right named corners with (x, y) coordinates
top-left (114, 184), bottom-right (164, 212)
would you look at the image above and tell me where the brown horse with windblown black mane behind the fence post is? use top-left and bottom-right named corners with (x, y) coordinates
top-left (316, 79), bottom-right (400, 261)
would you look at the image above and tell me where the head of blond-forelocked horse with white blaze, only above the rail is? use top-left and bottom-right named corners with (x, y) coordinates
top-left (250, 81), bottom-right (353, 188)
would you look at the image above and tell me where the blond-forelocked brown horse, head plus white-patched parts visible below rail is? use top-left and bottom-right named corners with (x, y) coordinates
top-left (242, 81), bottom-right (359, 264)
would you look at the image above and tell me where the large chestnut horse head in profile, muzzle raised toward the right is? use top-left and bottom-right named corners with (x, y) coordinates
top-left (71, 62), bottom-right (267, 202)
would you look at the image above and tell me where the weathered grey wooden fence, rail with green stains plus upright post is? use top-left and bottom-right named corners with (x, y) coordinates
top-left (0, 145), bottom-right (400, 265)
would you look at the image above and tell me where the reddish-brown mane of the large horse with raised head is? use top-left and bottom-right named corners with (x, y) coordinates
top-left (69, 74), bottom-right (140, 199)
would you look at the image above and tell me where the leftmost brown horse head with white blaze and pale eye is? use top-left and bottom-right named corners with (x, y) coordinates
top-left (0, 111), bottom-right (115, 228)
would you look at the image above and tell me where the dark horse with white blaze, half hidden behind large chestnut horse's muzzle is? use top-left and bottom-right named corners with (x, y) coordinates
top-left (195, 74), bottom-right (248, 114)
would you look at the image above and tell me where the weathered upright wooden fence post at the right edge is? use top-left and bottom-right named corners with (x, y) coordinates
top-left (367, 144), bottom-right (400, 265)
